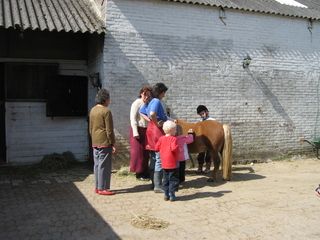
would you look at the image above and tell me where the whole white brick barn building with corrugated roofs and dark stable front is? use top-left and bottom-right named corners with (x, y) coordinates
top-left (0, 0), bottom-right (320, 164)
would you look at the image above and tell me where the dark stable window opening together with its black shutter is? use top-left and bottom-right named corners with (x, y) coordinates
top-left (5, 63), bottom-right (88, 117)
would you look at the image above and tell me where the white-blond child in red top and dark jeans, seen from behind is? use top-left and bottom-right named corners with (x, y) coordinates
top-left (155, 121), bottom-right (179, 201)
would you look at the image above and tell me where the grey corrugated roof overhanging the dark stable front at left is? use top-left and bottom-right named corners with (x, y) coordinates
top-left (0, 0), bottom-right (105, 34)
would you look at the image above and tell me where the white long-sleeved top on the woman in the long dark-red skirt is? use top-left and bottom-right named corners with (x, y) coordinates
top-left (130, 98), bottom-right (148, 137)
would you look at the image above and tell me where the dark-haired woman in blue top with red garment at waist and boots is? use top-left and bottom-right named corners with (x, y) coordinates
top-left (140, 83), bottom-right (168, 193)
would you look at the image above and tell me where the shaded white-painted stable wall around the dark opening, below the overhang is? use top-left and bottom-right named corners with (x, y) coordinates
top-left (6, 59), bottom-right (92, 164)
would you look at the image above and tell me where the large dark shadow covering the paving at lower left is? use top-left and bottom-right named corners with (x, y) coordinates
top-left (0, 162), bottom-right (120, 239)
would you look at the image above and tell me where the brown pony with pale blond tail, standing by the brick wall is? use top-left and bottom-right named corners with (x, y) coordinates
top-left (176, 119), bottom-right (232, 182)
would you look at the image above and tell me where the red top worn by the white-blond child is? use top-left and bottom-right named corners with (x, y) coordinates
top-left (155, 136), bottom-right (179, 169)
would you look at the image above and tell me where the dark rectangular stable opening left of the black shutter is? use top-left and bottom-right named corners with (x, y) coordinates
top-left (5, 63), bottom-right (58, 101)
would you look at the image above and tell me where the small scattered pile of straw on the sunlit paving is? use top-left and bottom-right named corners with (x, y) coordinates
top-left (131, 215), bottom-right (169, 230)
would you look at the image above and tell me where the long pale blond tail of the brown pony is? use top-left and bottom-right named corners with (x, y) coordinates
top-left (222, 124), bottom-right (232, 181)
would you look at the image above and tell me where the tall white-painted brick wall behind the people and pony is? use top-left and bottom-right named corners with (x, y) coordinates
top-left (103, 0), bottom-right (320, 158)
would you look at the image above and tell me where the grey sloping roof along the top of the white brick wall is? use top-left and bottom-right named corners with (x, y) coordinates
top-left (167, 0), bottom-right (320, 20)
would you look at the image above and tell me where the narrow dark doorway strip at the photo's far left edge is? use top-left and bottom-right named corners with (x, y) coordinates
top-left (0, 63), bottom-right (6, 164)
